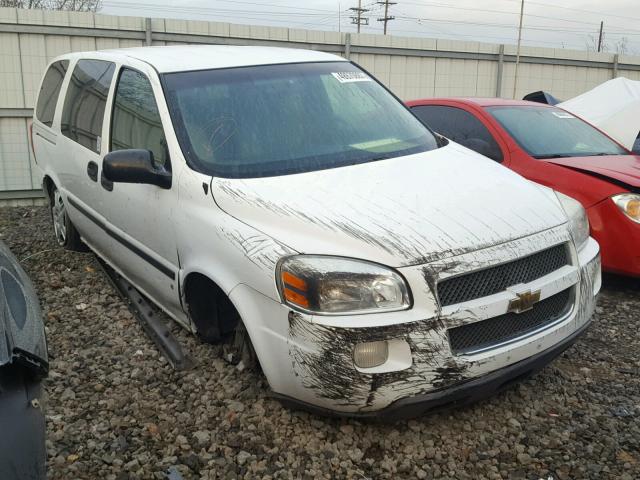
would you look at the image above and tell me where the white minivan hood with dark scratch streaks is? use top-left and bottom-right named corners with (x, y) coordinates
top-left (211, 142), bottom-right (566, 267)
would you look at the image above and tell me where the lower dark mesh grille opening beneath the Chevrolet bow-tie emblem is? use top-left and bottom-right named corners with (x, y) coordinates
top-left (448, 287), bottom-right (573, 354)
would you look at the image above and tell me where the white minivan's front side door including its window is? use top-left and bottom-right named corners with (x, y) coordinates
top-left (100, 66), bottom-right (181, 316)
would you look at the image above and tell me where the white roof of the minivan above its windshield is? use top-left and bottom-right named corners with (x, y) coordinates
top-left (90, 45), bottom-right (346, 73)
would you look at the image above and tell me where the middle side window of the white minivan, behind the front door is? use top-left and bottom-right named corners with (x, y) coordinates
top-left (60, 60), bottom-right (115, 153)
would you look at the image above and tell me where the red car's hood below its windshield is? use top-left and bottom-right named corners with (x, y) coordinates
top-left (545, 155), bottom-right (640, 187)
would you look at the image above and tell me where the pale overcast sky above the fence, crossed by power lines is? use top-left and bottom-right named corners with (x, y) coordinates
top-left (101, 0), bottom-right (640, 55)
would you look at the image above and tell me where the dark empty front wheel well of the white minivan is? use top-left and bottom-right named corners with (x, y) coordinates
top-left (184, 273), bottom-right (240, 343)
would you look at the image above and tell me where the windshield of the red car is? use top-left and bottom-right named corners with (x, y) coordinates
top-left (487, 106), bottom-right (628, 158)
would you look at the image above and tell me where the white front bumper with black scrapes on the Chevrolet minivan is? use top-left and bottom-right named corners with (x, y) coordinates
top-left (231, 228), bottom-right (601, 418)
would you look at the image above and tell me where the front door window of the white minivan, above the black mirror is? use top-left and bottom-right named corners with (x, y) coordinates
top-left (111, 68), bottom-right (168, 169)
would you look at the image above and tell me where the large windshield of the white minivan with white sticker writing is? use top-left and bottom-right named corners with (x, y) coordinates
top-left (163, 62), bottom-right (437, 178)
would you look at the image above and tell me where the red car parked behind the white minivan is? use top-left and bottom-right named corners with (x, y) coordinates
top-left (407, 98), bottom-right (640, 276)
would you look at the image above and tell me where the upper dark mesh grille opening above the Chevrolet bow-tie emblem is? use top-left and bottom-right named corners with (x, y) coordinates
top-left (438, 243), bottom-right (569, 307)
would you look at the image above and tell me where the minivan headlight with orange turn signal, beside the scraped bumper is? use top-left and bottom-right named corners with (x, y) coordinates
top-left (277, 255), bottom-right (411, 315)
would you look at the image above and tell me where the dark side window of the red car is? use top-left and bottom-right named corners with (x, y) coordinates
top-left (412, 105), bottom-right (502, 162)
